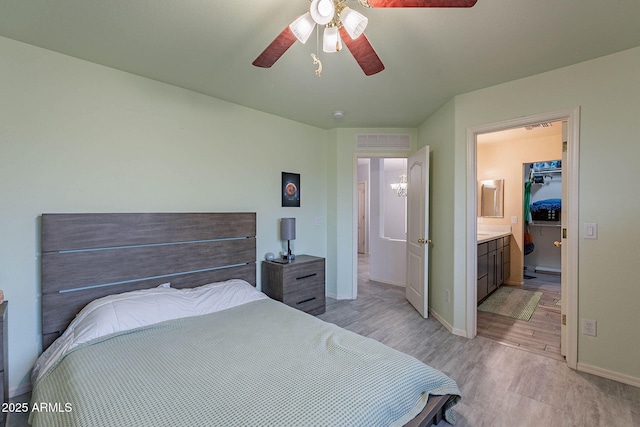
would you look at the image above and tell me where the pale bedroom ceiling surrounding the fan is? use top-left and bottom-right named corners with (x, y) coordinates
top-left (0, 0), bottom-right (640, 129)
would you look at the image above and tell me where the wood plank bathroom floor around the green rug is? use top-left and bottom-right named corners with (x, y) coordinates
top-left (477, 273), bottom-right (564, 360)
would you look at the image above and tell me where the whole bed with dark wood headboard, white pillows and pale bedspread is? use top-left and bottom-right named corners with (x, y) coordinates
top-left (29, 212), bottom-right (460, 426)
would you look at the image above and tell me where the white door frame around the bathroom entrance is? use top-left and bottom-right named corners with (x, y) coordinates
top-left (466, 107), bottom-right (580, 369)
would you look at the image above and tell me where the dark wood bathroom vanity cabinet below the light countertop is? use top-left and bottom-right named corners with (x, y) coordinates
top-left (477, 235), bottom-right (511, 303)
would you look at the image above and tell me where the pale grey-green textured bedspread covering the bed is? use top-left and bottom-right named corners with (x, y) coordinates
top-left (30, 300), bottom-right (460, 427)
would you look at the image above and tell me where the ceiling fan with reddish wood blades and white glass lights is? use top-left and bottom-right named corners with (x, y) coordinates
top-left (253, 0), bottom-right (477, 76)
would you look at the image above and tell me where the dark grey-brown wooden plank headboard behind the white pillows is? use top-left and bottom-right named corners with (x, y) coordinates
top-left (42, 212), bottom-right (256, 350)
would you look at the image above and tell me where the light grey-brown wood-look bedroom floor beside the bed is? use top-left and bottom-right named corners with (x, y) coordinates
top-left (8, 260), bottom-right (640, 427)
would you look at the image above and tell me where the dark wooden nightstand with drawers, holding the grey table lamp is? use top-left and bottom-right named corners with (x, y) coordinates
top-left (262, 255), bottom-right (325, 315)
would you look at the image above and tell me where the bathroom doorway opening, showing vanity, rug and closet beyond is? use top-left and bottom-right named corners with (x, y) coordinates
top-left (476, 125), bottom-right (564, 360)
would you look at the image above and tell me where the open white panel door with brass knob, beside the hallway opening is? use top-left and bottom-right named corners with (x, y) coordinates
top-left (406, 147), bottom-right (429, 317)
